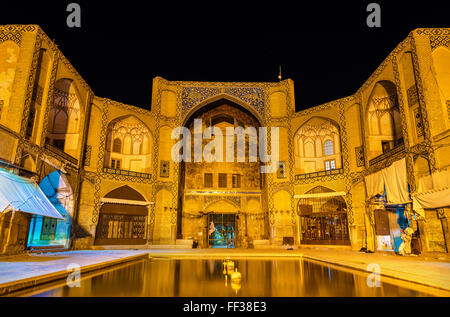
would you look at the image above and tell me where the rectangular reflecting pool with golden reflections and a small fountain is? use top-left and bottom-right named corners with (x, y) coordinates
top-left (13, 258), bottom-right (449, 297)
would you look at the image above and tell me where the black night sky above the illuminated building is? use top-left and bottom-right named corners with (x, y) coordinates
top-left (0, 0), bottom-right (450, 110)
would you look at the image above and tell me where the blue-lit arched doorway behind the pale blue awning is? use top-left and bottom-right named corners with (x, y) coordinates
top-left (28, 171), bottom-right (74, 247)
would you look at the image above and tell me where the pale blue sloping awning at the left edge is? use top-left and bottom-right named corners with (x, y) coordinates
top-left (0, 169), bottom-right (64, 219)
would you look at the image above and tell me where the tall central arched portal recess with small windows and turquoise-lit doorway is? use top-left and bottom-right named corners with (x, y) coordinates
top-left (177, 97), bottom-right (268, 248)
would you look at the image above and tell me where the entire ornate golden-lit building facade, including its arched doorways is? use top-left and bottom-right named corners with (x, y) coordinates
top-left (0, 25), bottom-right (450, 253)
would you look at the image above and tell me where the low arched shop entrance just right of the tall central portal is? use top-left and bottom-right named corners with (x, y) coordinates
top-left (297, 186), bottom-right (350, 245)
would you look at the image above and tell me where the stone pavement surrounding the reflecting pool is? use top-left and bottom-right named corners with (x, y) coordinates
top-left (0, 247), bottom-right (450, 295)
